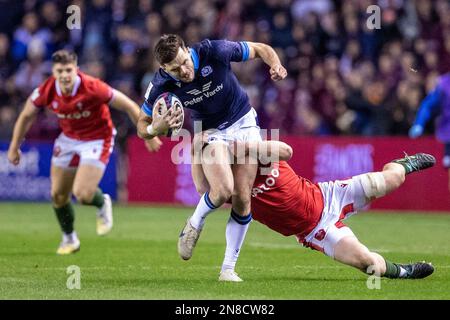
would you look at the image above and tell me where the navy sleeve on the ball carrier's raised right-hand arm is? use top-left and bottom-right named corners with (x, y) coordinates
top-left (209, 40), bottom-right (250, 63)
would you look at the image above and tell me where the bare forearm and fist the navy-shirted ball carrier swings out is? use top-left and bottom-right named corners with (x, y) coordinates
top-left (247, 42), bottom-right (287, 81)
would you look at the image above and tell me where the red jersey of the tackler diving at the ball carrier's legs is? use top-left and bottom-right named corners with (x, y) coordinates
top-left (251, 161), bottom-right (324, 237)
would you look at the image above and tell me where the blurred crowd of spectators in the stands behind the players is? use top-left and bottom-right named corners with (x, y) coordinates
top-left (0, 0), bottom-right (450, 142)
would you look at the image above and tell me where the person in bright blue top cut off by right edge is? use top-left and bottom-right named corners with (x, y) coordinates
top-left (409, 73), bottom-right (450, 190)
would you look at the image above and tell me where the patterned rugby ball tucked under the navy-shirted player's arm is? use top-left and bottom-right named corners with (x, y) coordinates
top-left (153, 92), bottom-right (184, 137)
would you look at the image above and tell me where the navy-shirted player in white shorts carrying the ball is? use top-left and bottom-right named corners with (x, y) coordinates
top-left (138, 35), bottom-right (287, 272)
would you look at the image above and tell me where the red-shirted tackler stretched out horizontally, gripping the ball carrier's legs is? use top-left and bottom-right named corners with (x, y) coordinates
top-left (192, 137), bottom-right (436, 282)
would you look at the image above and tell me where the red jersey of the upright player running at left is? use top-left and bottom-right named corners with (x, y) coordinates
top-left (31, 72), bottom-right (114, 140)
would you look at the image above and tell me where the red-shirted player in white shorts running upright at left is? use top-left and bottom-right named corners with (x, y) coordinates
top-left (8, 50), bottom-right (161, 255)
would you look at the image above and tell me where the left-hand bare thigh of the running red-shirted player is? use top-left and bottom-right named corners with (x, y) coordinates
top-left (50, 165), bottom-right (76, 205)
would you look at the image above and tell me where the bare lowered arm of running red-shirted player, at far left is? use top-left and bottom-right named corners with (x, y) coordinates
top-left (8, 98), bottom-right (39, 165)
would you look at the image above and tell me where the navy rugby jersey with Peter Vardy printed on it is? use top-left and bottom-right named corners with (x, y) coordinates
top-left (142, 39), bottom-right (251, 130)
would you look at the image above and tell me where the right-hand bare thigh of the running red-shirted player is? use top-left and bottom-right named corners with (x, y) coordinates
top-left (73, 164), bottom-right (105, 200)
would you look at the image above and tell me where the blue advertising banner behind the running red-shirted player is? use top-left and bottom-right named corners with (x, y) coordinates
top-left (0, 142), bottom-right (117, 201)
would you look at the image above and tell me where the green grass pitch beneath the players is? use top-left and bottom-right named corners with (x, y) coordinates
top-left (0, 203), bottom-right (450, 300)
